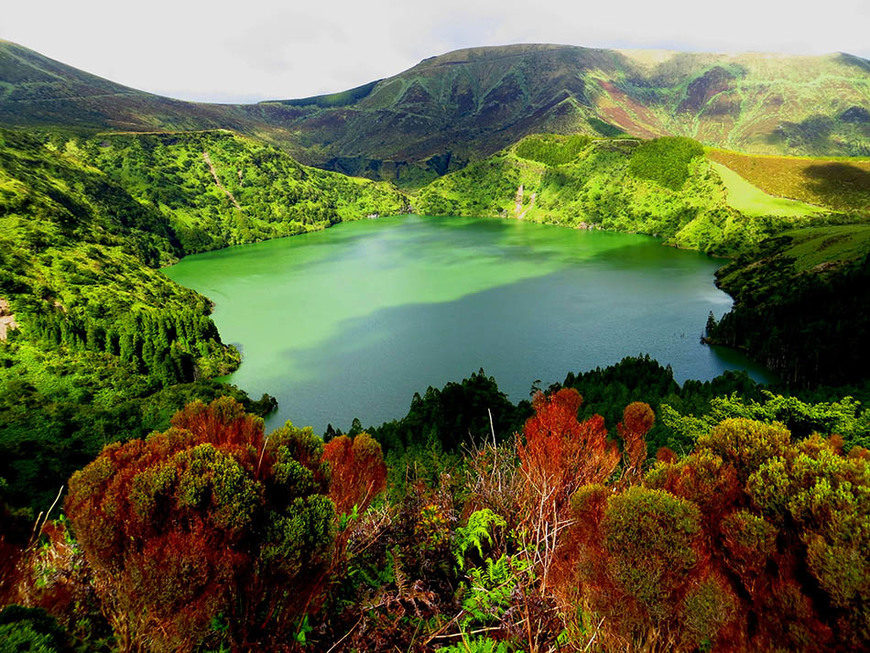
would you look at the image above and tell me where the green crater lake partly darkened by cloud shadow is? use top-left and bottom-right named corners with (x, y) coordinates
top-left (164, 216), bottom-right (769, 433)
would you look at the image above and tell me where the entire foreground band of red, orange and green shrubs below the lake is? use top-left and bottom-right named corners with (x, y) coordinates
top-left (0, 359), bottom-right (870, 653)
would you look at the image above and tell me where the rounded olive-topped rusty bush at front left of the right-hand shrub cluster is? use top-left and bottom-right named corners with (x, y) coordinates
top-left (567, 485), bottom-right (738, 651)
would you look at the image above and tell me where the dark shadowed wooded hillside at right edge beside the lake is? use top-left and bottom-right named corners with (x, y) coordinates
top-left (708, 224), bottom-right (870, 386)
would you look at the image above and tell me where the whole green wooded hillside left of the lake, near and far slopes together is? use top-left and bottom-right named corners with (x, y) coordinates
top-left (0, 131), bottom-right (404, 512)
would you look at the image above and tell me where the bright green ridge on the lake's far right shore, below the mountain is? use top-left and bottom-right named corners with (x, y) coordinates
top-left (414, 135), bottom-right (858, 255)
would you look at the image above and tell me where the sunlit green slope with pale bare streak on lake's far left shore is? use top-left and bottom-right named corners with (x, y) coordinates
top-left (82, 131), bottom-right (407, 254)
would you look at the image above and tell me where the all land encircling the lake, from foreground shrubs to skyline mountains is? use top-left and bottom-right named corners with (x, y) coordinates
top-left (0, 42), bottom-right (870, 653)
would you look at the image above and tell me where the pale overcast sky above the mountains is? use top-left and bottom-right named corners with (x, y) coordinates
top-left (0, 0), bottom-right (870, 102)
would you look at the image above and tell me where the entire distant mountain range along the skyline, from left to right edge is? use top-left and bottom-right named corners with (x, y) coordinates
top-left (0, 42), bottom-right (870, 186)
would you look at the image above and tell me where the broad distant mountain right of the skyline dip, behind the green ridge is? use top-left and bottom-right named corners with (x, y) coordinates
top-left (268, 45), bottom-right (870, 178)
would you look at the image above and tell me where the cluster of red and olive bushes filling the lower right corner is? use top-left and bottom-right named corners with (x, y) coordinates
top-left (556, 418), bottom-right (870, 652)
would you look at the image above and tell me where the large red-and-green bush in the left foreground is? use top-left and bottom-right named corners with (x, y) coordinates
top-left (66, 398), bottom-right (333, 651)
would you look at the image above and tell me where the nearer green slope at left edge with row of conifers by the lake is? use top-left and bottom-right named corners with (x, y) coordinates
top-left (0, 127), bottom-right (237, 384)
